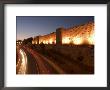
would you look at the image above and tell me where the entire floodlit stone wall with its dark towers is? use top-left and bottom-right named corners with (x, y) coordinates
top-left (32, 22), bottom-right (94, 45)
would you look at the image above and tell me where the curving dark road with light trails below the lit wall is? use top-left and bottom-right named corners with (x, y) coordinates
top-left (16, 46), bottom-right (65, 74)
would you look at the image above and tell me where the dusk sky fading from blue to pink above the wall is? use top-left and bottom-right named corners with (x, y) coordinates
top-left (16, 16), bottom-right (94, 40)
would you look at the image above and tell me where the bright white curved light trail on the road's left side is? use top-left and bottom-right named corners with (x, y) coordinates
top-left (18, 49), bottom-right (27, 74)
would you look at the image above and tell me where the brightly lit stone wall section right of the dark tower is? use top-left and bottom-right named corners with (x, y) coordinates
top-left (62, 22), bottom-right (94, 45)
